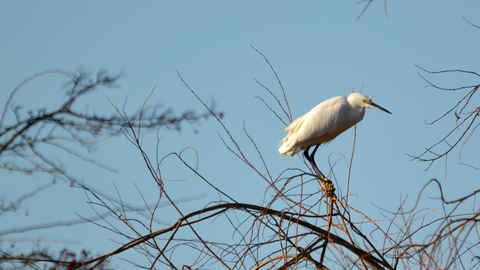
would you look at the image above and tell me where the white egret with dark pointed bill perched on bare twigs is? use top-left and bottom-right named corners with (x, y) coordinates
top-left (278, 93), bottom-right (392, 179)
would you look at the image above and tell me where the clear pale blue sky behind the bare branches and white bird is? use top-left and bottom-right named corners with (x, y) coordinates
top-left (0, 1), bottom-right (480, 268)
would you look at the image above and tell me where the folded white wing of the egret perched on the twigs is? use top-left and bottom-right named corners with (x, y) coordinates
top-left (297, 97), bottom-right (349, 142)
